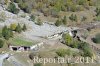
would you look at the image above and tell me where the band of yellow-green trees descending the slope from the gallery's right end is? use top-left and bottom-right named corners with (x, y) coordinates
top-left (62, 33), bottom-right (93, 57)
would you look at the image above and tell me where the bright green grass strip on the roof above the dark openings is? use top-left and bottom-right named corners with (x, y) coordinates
top-left (11, 38), bottom-right (37, 46)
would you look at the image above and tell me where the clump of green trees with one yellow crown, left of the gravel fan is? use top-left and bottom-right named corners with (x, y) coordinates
top-left (1, 23), bottom-right (27, 40)
